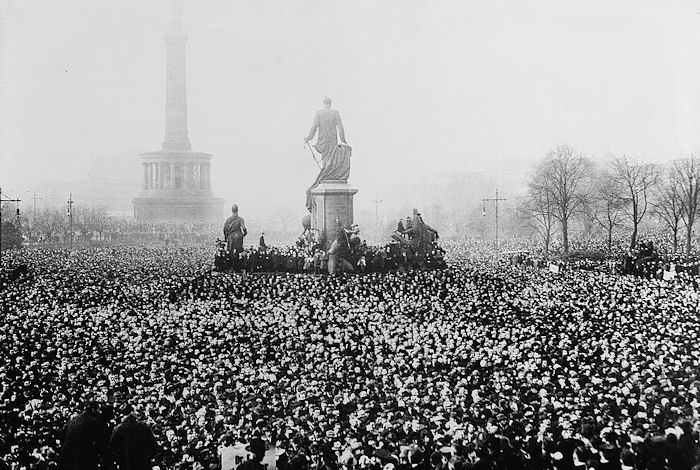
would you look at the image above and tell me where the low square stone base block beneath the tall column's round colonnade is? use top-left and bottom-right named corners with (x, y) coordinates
top-left (134, 197), bottom-right (224, 222)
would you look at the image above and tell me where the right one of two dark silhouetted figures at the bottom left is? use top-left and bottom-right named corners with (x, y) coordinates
top-left (109, 407), bottom-right (157, 470)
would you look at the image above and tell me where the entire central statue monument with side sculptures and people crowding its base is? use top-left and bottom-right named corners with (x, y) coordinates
top-left (214, 92), bottom-right (444, 274)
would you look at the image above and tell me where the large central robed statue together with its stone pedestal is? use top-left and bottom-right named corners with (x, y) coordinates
top-left (304, 97), bottom-right (357, 249)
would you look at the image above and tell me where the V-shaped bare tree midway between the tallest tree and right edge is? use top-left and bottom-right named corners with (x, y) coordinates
top-left (609, 156), bottom-right (659, 248)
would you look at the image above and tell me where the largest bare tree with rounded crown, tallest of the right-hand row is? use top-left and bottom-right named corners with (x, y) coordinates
top-left (532, 145), bottom-right (593, 253)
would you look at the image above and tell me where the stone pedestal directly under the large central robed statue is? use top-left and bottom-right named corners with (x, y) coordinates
top-left (311, 180), bottom-right (357, 249)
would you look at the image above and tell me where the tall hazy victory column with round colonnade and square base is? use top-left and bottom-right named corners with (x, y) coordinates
top-left (134, 5), bottom-right (224, 222)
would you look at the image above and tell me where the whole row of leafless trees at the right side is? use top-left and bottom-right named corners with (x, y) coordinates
top-left (518, 145), bottom-right (700, 254)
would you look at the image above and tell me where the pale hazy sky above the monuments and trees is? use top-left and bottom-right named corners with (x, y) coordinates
top-left (0, 0), bottom-right (700, 212)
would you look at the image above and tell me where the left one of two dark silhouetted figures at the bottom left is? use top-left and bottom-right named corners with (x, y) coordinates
top-left (59, 403), bottom-right (108, 470)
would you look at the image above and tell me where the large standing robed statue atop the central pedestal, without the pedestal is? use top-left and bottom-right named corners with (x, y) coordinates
top-left (304, 96), bottom-right (352, 212)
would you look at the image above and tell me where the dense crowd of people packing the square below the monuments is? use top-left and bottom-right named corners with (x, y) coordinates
top-left (0, 242), bottom-right (700, 470)
